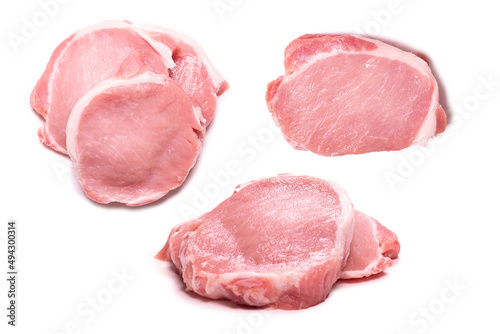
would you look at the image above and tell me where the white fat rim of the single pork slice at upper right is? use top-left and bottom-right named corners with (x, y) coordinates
top-left (272, 35), bottom-right (439, 148)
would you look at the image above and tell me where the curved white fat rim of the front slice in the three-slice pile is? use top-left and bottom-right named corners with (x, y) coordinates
top-left (66, 71), bottom-right (166, 161)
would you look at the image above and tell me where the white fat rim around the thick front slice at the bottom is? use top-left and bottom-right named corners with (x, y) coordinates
top-left (179, 174), bottom-right (354, 306)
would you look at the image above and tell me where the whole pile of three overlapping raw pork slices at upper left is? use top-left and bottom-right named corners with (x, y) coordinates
top-left (31, 20), bottom-right (228, 205)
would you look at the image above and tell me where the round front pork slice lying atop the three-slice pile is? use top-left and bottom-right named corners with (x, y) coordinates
top-left (67, 53), bottom-right (203, 206)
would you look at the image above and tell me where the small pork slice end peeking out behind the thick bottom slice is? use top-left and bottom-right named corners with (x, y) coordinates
top-left (340, 211), bottom-right (400, 279)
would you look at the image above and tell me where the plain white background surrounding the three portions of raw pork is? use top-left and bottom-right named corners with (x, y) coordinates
top-left (0, 0), bottom-right (500, 334)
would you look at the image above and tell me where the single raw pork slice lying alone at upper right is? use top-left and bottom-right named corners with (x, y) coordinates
top-left (266, 35), bottom-right (446, 156)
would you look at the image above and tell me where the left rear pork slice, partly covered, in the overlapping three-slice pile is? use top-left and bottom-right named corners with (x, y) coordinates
top-left (31, 21), bottom-right (173, 153)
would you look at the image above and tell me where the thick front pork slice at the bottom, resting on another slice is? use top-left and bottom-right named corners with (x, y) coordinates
top-left (156, 175), bottom-right (397, 309)
